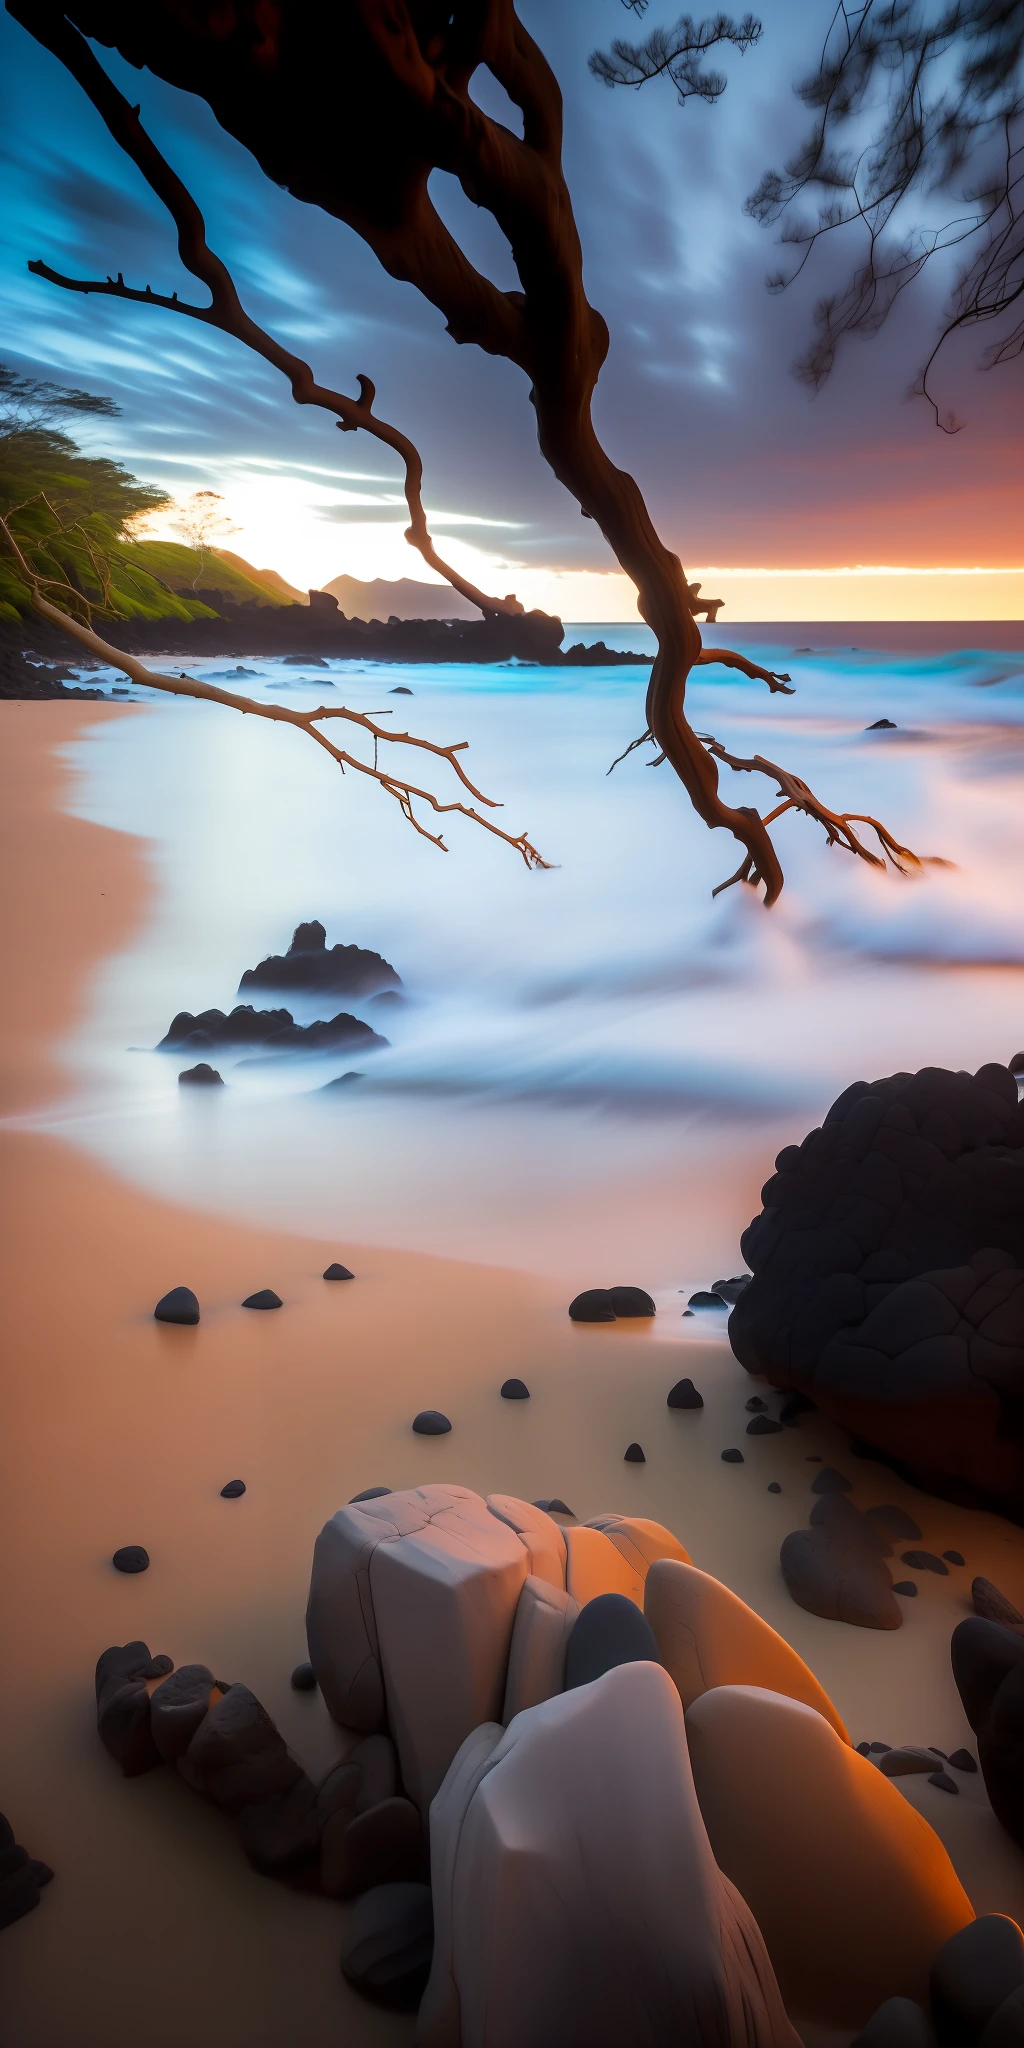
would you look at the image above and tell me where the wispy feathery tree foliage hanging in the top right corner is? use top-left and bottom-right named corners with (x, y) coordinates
top-left (590, 0), bottom-right (1024, 434)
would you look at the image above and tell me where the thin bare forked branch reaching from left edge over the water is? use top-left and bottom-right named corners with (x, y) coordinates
top-left (0, 516), bottom-right (551, 868)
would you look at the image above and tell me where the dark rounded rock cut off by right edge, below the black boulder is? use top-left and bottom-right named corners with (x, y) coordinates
top-left (950, 1616), bottom-right (1024, 1847)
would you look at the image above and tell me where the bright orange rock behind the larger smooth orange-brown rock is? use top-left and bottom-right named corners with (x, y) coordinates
top-left (643, 1559), bottom-right (850, 1743)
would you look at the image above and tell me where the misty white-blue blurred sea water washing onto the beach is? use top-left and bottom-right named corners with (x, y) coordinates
top-left (25, 625), bottom-right (1024, 1277)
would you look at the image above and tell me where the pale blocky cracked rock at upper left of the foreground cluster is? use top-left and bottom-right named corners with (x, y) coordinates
top-left (305, 1485), bottom-right (528, 1817)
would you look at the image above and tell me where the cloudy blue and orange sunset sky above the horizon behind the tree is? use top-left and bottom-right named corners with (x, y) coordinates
top-left (0, 0), bottom-right (1024, 621)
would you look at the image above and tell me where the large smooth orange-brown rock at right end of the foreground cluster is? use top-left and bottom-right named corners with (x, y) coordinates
top-left (686, 1686), bottom-right (973, 2030)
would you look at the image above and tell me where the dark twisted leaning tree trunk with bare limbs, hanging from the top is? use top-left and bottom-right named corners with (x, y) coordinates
top-left (6, 0), bottom-right (920, 903)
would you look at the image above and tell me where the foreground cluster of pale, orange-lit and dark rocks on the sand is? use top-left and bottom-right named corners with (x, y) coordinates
top-left (96, 1485), bottom-right (991, 2048)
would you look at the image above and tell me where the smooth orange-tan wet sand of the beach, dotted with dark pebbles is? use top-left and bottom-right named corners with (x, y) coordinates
top-left (0, 702), bottom-right (1024, 2048)
